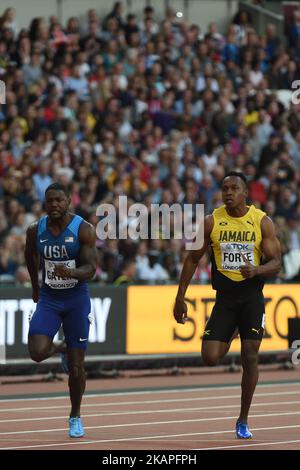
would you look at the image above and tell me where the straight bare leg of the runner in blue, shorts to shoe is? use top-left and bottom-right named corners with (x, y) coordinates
top-left (67, 349), bottom-right (86, 416)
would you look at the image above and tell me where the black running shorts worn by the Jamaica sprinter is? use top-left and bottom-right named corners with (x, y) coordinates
top-left (203, 291), bottom-right (265, 343)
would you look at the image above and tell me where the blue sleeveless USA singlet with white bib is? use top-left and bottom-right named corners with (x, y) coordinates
top-left (36, 215), bottom-right (87, 293)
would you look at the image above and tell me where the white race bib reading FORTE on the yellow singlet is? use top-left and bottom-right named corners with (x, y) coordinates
top-left (220, 243), bottom-right (255, 271)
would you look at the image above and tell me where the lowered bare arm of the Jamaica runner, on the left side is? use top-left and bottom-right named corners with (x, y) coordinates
top-left (173, 215), bottom-right (214, 323)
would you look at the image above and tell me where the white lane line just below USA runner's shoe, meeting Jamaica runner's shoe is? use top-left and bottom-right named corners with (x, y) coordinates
top-left (0, 424), bottom-right (300, 450)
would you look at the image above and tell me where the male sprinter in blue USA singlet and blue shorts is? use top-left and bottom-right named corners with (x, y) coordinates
top-left (25, 183), bottom-right (97, 437)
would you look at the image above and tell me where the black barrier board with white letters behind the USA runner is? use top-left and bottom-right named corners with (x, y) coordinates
top-left (0, 287), bottom-right (127, 359)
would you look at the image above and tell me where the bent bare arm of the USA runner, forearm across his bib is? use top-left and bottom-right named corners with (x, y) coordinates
top-left (54, 222), bottom-right (98, 281)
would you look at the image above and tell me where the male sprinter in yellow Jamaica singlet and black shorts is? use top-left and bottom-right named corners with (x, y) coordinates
top-left (174, 171), bottom-right (281, 439)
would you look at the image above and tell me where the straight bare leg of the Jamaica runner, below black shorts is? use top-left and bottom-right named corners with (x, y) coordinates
top-left (238, 339), bottom-right (261, 423)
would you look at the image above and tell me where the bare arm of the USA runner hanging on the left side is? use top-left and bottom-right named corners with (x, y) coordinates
top-left (24, 222), bottom-right (40, 302)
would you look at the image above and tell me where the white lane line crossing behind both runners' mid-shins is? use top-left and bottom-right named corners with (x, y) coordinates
top-left (0, 382), bottom-right (300, 405)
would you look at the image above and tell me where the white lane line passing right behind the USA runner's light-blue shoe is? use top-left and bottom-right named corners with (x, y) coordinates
top-left (0, 411), bottom-right (300, 436)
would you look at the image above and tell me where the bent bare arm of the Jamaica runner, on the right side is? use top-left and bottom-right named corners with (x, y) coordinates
top-left (241, 216), bottom-right (281, 279)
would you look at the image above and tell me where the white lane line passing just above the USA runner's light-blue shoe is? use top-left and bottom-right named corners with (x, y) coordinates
top-left (0, 400), bottom-right (300, 423)
